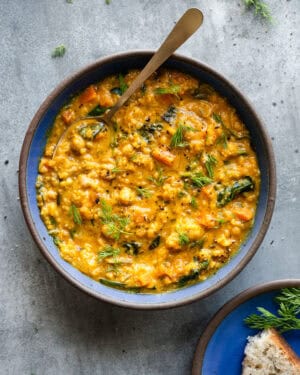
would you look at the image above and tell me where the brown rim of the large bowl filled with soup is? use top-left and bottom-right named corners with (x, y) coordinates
top-left (19, 50), bottom-right (276, 310)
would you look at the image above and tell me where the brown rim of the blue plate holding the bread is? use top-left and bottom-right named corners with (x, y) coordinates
top-left (192, 279), bottom-right (300, 375)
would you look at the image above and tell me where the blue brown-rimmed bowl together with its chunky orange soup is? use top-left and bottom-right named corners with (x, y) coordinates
top-left (19, 51), bottom-right (276, 309)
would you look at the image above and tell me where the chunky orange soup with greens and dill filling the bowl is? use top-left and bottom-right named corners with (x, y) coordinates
top-left (36, 70), bottom-right (260, 293)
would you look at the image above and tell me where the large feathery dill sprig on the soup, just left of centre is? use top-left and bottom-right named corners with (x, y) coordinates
top-left (100, 199), bottom-right (129, 240)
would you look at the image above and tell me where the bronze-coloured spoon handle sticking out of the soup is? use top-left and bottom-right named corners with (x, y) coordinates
top-left (104, 8), bottom-right (203, 122)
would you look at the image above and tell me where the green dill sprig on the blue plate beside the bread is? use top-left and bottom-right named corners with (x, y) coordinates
top-left (244, 288), bottom-right (300, 333)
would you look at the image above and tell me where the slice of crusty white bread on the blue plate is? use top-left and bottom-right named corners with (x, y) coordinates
top-left (242, 328), bottom-right (300, 375)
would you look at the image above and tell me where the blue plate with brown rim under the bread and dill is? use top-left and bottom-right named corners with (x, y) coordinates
top-left (192, 280), bottom-right (300, 375)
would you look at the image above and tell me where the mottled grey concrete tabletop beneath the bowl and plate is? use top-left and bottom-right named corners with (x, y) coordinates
top-left (0, 0), bottom-right (300, 375)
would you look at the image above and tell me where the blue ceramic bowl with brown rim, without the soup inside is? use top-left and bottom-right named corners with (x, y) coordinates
top-left (19, 51), bottom-right (276, 309)
